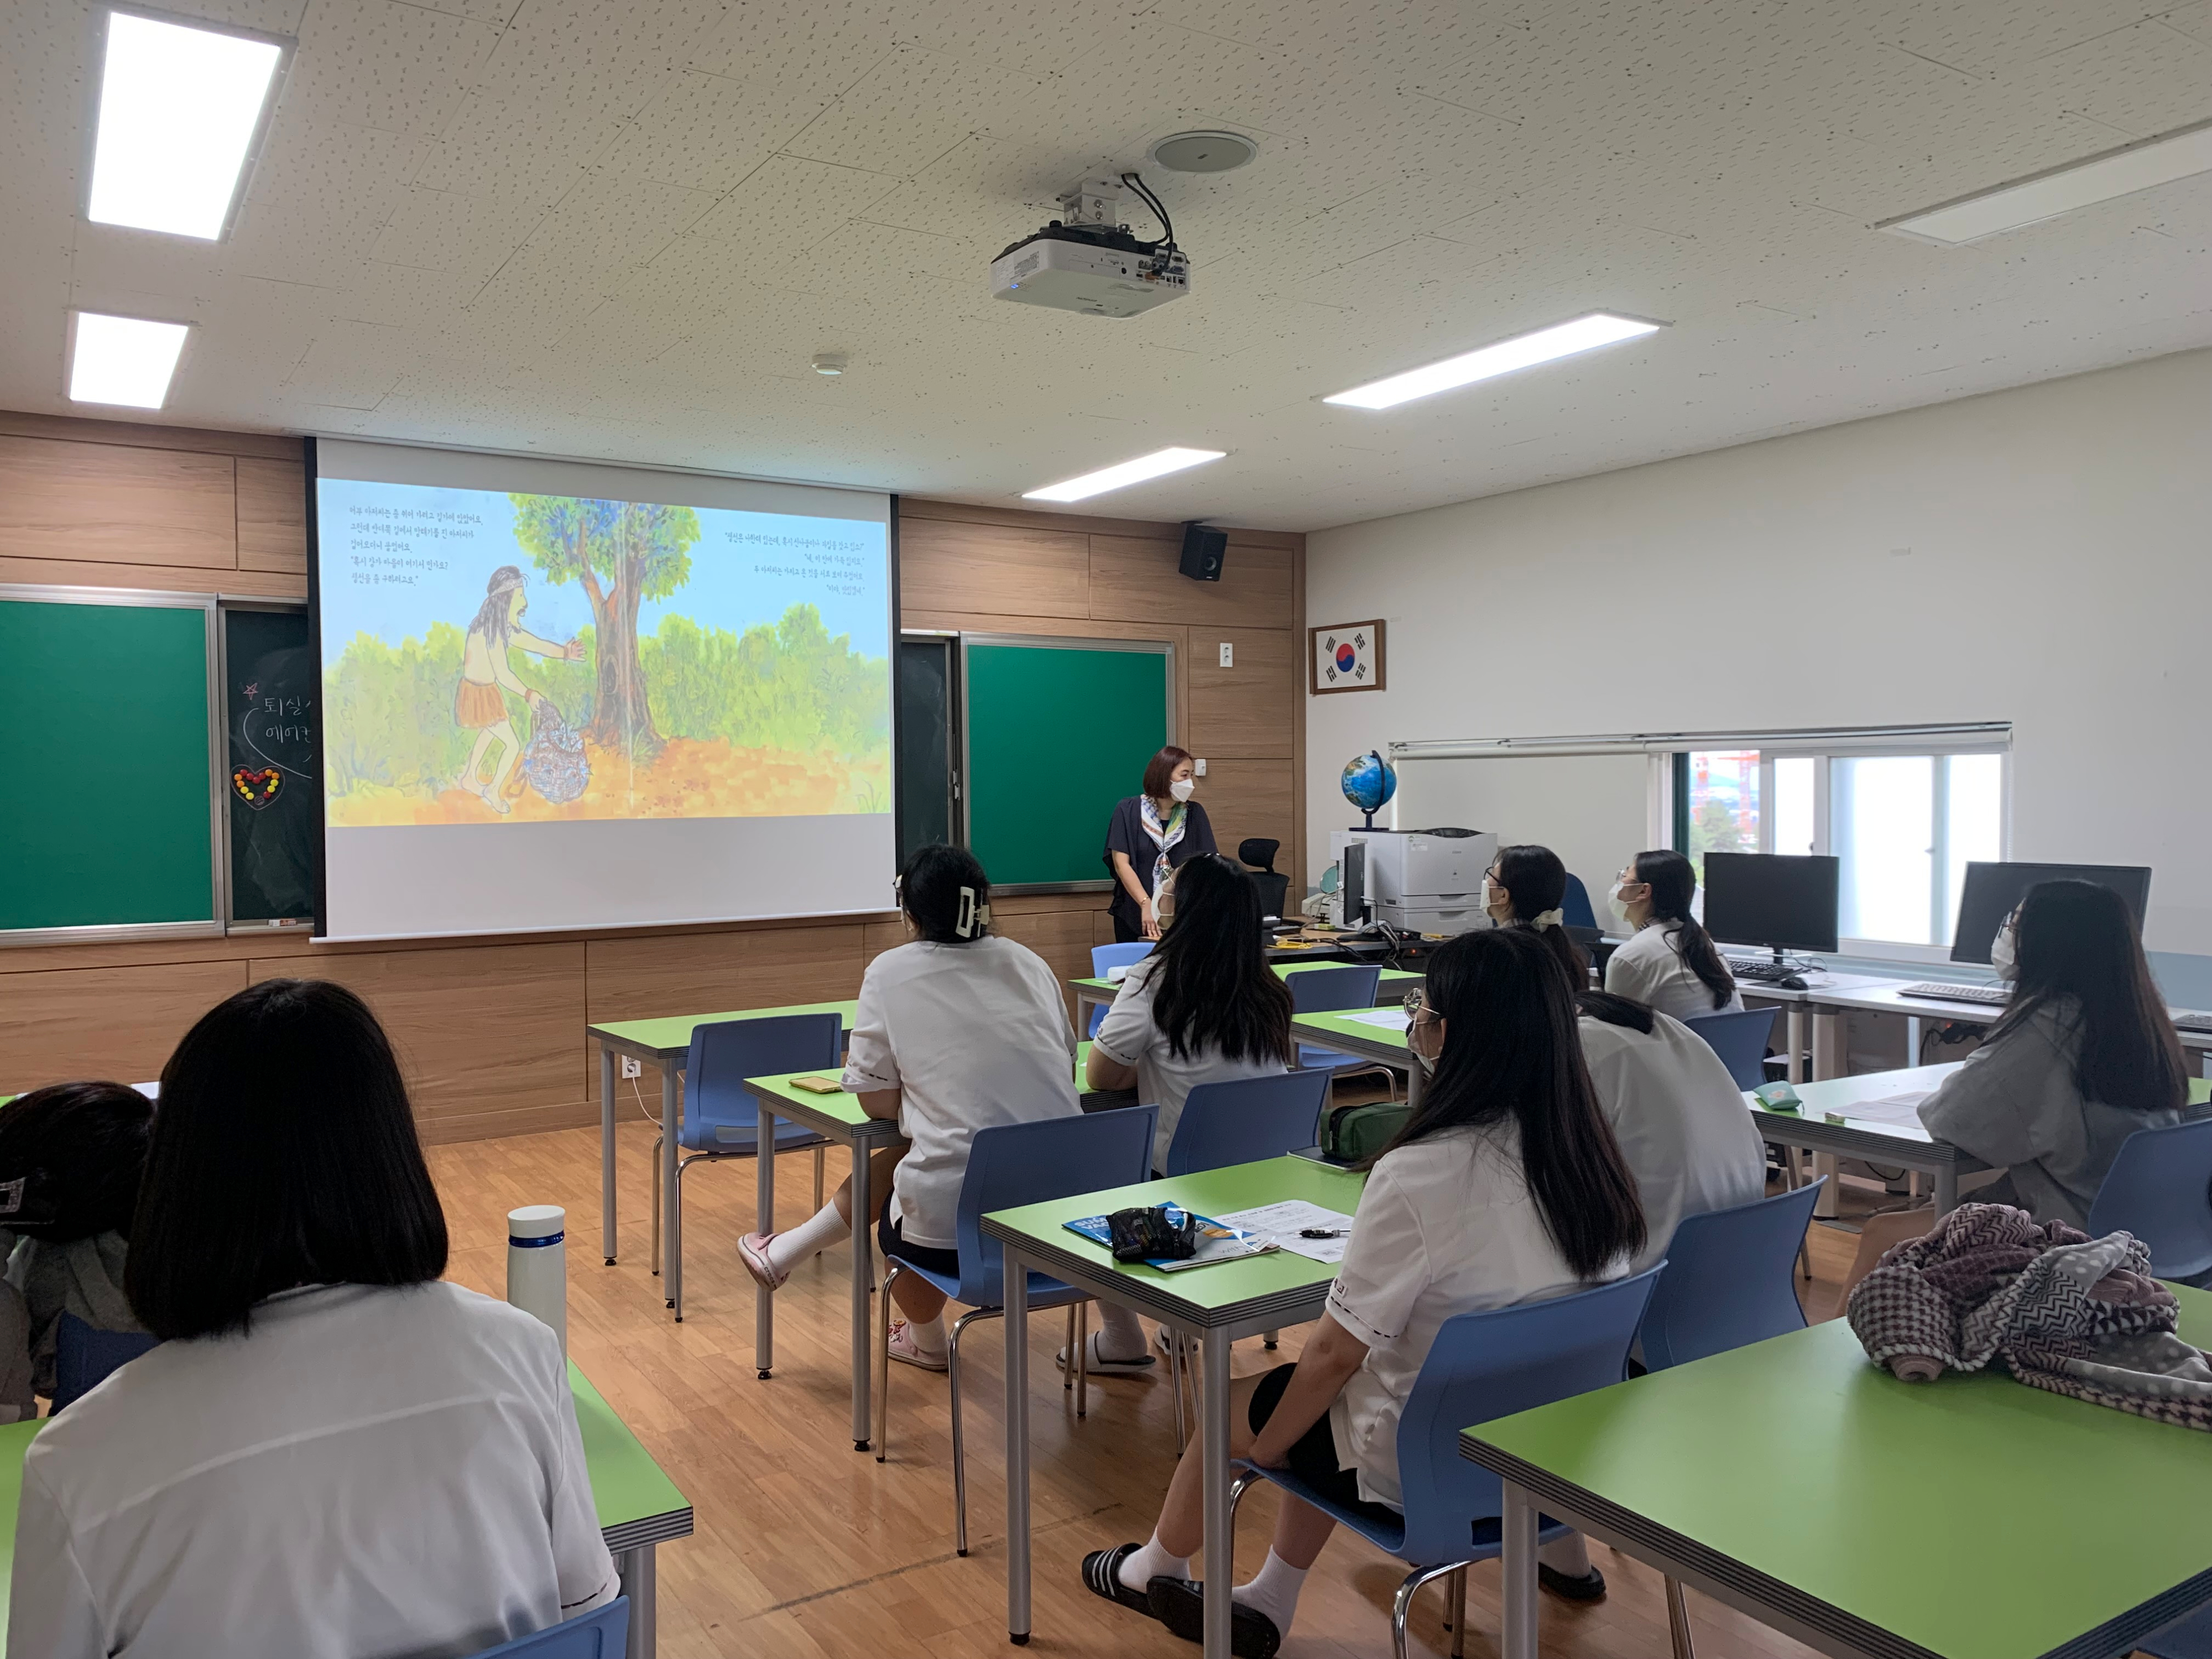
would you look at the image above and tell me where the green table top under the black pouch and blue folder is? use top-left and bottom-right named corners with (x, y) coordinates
top-left (982, 1157), bottom-right (1367, 1323)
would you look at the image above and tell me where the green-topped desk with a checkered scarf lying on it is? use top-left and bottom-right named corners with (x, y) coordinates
top-left (1460, 1290), bottom-right (2212, 1659)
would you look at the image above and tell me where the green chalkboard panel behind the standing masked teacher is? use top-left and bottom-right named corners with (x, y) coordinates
top-left (960, 635), bottom-right (1175, 887)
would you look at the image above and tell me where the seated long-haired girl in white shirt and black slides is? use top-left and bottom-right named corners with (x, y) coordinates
top-left (1082, 927), bottom-right (1644, 1659)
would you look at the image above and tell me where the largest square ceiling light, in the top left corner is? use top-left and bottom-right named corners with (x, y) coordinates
top-left (84, 11), bottom-right (283, 241)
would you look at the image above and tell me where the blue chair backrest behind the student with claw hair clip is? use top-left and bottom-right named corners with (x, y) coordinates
top-left (953, 1106), bottom-right (1159, 1307)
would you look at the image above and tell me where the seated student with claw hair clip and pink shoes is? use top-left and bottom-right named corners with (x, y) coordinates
top-left (737, 847), bottom-right (1082, 1371)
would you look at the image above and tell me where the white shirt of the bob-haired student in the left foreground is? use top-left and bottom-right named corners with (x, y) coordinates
top-left (9, 1283), bottom-right (619, 1659)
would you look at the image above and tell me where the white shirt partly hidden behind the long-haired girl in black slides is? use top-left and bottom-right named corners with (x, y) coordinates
top-left (1579, 1013), bottom-right (1767, 1272)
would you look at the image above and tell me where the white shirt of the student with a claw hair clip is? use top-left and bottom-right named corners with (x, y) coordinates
top-left (845, 933), bottom-right (1082, 1250)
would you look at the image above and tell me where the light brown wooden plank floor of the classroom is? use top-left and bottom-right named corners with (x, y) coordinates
top-left (431, 1119), bottom-right (1856, 1659)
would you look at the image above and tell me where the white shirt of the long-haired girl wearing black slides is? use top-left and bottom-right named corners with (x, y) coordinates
top-left (1329, 1124), bottom-right (1615, 1506)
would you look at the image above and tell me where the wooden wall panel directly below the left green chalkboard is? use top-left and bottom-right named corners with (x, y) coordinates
top-left (0, 949), bottom-right (248, 1095)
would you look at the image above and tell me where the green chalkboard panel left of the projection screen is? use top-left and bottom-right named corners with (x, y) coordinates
top-left (0, 588), bottom-right (217, 933)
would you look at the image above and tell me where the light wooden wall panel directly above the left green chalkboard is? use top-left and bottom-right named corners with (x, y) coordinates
top-left (0, 436), bottom-right (239, 571)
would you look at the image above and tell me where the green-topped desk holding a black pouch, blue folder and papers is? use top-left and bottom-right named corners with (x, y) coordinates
top-left (982, 1157), bottom-right (1367, 1659)
